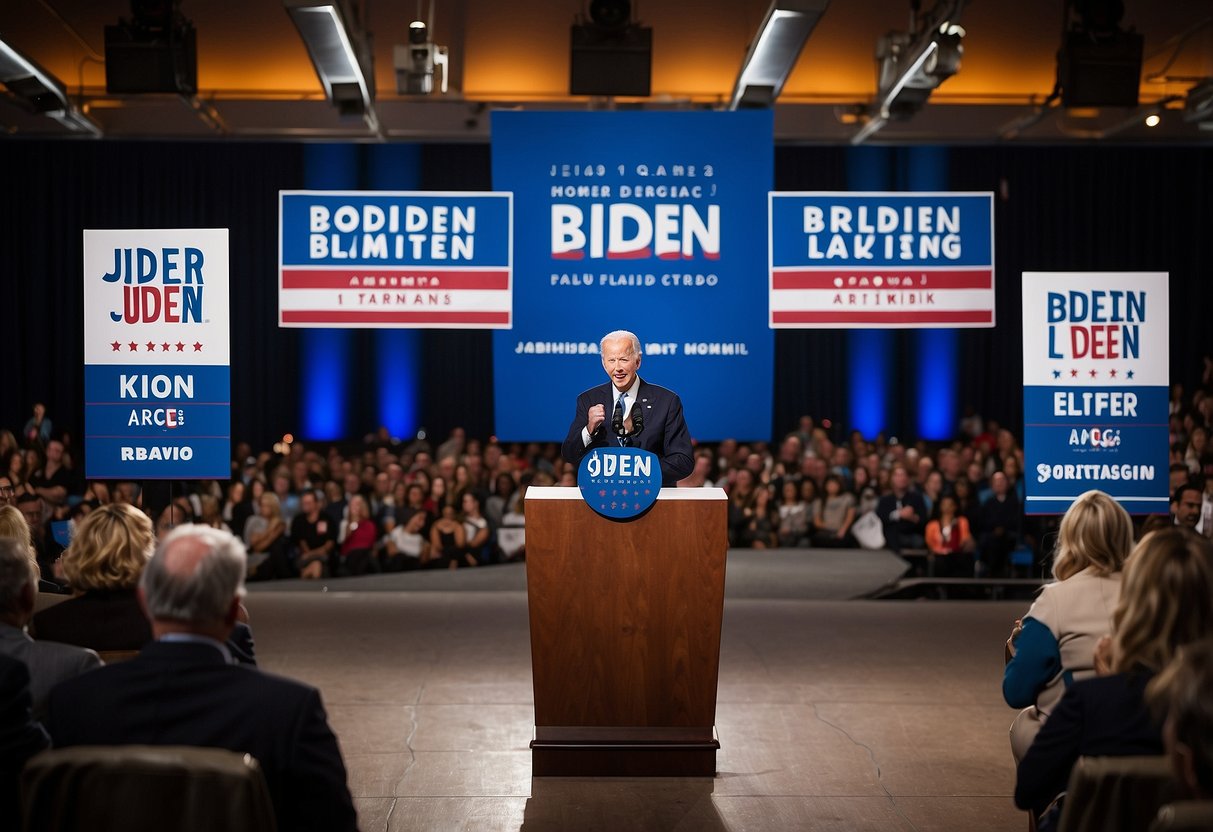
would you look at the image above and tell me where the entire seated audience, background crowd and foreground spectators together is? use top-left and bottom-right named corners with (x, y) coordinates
top-left (0, 378), bottom-right (1213, 828)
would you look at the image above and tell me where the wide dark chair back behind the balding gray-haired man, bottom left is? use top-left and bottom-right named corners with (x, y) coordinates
top-left (21, 746), bottom-right (277, 832)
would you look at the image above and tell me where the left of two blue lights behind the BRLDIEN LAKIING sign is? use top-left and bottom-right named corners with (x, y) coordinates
top-left (847, 146), bottom-right (896, 439)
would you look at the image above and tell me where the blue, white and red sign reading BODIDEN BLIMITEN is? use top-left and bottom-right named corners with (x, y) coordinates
top-left (278, 190), bottom-right (513, 329)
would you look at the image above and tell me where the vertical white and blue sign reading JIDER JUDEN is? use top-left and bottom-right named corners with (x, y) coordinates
top-left (84, 228), bottom-right (232, 479)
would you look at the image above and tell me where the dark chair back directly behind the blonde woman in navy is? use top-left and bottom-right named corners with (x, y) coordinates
top-left (1058, 756), bottom-right (1174, 832)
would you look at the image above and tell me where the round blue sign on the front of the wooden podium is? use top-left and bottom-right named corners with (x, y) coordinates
top-left (577, 448), bottom-right (661, 520)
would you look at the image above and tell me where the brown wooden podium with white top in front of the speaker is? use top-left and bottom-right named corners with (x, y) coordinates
top-left (525, 488), bottom-right (728, 777)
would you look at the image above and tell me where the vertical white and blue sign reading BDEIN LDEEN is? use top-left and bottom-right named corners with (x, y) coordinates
top-left (1024, 273), bottom-right (1169, 514)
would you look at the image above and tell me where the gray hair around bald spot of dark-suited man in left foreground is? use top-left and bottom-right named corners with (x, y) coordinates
top-left (139, 523), bottom-right (247, 623)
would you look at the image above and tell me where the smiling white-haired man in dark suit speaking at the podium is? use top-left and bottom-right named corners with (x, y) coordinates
top-left (560, 330), bottom-right (695, 486)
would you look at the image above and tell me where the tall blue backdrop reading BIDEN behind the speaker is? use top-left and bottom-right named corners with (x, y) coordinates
top-left (492, 110), bottom-right (774, 441)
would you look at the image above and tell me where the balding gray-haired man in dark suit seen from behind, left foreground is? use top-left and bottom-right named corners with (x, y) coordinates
top-left (46, 525), bottom-right (357, 832)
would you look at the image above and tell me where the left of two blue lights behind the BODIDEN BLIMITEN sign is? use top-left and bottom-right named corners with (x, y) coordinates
top-left (300, 144), bottom-right (358, 440)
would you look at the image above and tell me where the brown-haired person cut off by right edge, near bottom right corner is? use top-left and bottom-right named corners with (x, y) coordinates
top-left (1146, 638), bottom-right (1213, 800)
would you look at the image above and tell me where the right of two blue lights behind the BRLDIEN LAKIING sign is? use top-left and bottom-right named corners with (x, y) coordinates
top-left (906, 147), bottom-right (959, 441)
